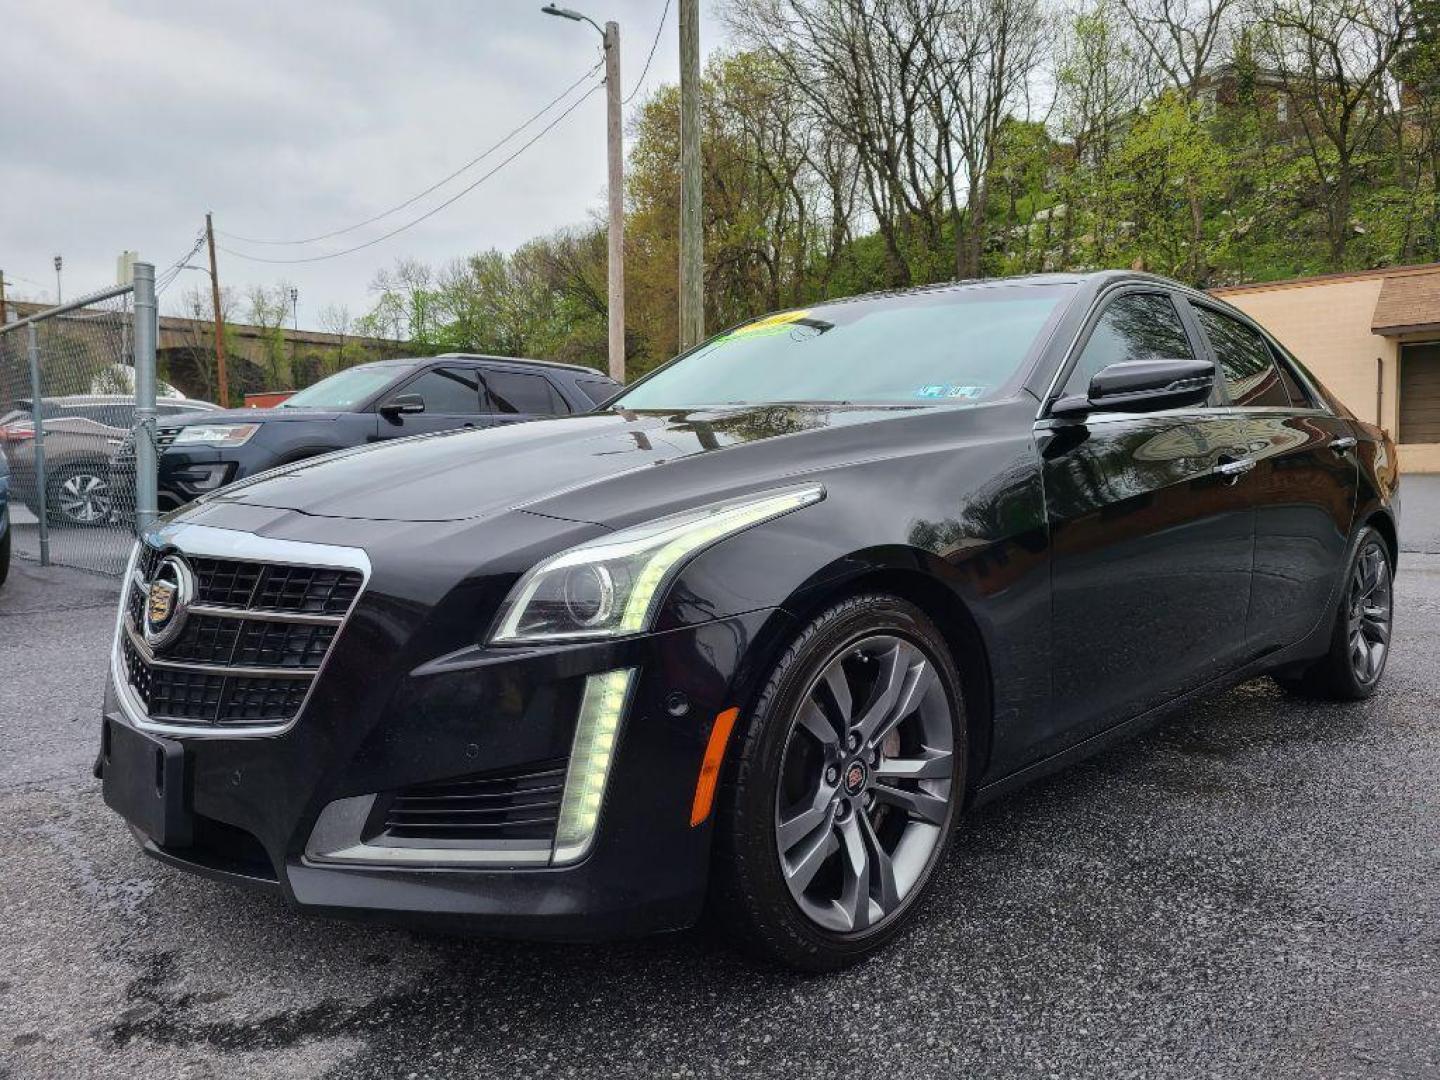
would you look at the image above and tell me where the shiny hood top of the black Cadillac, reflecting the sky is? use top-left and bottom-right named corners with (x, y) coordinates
top-left (204, 406), bottom-right (949, 524)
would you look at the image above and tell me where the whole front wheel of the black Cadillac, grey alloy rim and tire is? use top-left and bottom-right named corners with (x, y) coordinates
top-left (710, 595), bottom-right (966, 971)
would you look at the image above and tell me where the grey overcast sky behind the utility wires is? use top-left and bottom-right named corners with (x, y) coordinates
top-left (0, 0), bottom-right (721, 327)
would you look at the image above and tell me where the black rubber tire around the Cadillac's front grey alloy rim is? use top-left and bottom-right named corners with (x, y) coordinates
top-left (708, 595), bottom-right (966, 972)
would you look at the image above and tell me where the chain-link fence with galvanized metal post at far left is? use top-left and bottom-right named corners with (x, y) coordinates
top-left (0, 264), bottom-right (156, 575)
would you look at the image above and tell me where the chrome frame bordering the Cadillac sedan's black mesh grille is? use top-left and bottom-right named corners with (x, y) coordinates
top-left (109, 521), bottom-right (372, 739)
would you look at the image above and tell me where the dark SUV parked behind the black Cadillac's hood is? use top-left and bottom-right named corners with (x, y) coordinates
top-left (157, 353), bottom-right (621, 510)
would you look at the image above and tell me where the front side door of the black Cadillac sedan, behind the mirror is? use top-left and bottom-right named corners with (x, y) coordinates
top-left (1034, 288), bottom-right (1254, 756)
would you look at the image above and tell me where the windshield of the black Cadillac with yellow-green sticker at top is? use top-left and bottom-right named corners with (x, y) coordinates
top-left (611, 285), bottom-right (1073, 409)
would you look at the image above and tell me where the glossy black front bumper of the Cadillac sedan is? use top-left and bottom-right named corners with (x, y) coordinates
top-left (102, 598), bottom-right (789, 940)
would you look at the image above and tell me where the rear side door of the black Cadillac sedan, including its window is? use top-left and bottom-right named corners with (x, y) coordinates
top-left (1191, 301), bottom-right (1359, 654)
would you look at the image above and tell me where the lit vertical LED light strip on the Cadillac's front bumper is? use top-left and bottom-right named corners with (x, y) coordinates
top-left (552, 668), bottom-right (635, 865)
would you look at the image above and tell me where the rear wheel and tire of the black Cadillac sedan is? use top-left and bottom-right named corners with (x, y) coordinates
top-left (1274, 526), bottom-right (1395, 701)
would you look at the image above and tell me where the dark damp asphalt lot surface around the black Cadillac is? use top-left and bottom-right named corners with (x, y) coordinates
top-left (0, 480), bottom-right (1440, 1080)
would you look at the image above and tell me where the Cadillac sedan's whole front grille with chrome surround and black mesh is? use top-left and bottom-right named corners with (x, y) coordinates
top-left (111, 523), bottom-right (370, 739)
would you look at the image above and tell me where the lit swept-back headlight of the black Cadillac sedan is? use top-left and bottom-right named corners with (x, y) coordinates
top-left (490, 484), bottom-right (825, 642)
